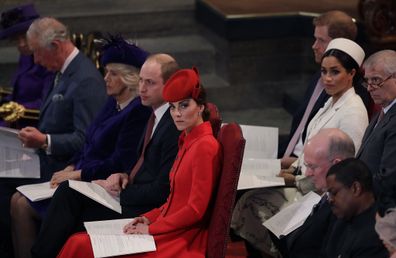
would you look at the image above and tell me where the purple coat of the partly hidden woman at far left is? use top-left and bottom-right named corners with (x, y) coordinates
top-left (0, 55), bottom-right (54, 128)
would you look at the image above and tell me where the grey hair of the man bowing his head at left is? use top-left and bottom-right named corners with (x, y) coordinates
top-left (26, 17), bottom-right (70, 48)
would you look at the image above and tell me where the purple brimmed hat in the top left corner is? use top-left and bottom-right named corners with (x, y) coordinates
top-left (0, 4), bottom-right (40, 39)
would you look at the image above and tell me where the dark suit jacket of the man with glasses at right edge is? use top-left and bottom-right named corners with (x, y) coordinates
top-left (356, 105), bottom-right (396, 213)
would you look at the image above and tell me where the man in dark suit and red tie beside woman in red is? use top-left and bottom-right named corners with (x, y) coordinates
top-left (32, 54), bottom-right (180, 257)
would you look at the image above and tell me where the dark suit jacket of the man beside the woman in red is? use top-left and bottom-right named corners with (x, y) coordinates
top-left (120, 109), bottom-right (180, 214)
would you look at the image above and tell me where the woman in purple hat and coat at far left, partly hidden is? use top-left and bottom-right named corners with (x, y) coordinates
top-left (0, 4), bottom-right (54, 128)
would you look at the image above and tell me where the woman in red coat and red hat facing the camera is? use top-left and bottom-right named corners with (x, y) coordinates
top-left (58, 69), bottom-right (221, 258)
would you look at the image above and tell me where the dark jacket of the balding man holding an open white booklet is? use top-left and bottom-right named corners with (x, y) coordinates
top-left (281, 197), bottom-right (336, 258)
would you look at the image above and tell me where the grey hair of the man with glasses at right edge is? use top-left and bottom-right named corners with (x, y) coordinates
top-left (363, 49), bottom-right (396, 75)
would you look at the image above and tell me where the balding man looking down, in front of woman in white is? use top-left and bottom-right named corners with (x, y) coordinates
top-left (278, 128), bottom-right (355, 258)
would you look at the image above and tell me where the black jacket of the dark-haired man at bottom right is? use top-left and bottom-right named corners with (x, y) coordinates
top-left (325, 205), bottom-right (389, 258)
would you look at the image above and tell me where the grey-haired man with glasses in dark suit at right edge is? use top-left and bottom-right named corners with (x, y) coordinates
top-left (356, 50), bottom-right (396, 215)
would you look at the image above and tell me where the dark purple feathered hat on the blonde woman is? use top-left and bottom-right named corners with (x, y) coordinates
top-left (101, 35), bottom-right (149, 68)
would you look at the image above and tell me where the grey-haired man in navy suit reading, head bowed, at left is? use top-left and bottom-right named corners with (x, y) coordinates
top-left (0, 17), bottom-right (106, 256)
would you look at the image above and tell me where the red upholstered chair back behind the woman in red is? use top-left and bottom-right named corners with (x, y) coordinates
top-left (206, 123), bottom-right (245, 258)
